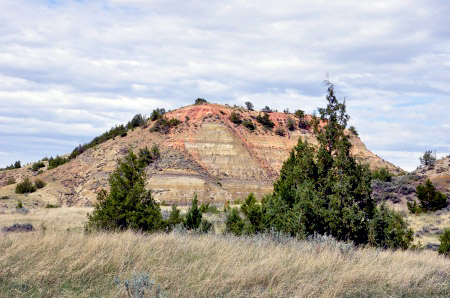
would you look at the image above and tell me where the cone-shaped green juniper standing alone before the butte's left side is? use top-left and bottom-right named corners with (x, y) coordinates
top-left (86, 151), bottom-right (164, 232)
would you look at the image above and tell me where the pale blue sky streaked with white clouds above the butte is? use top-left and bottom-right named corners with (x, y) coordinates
top-left (0, 0), bottom-right (450, 171)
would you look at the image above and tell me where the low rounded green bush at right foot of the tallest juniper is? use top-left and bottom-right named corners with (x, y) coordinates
top-left (369, 205), bottom-right (413, 249)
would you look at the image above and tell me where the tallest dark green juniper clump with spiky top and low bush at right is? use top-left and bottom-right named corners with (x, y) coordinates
top-left (234, 81), bottom-right (411, 248)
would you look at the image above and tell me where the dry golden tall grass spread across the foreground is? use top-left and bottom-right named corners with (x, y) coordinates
top-left (0, 231), bottom-right (450, 297)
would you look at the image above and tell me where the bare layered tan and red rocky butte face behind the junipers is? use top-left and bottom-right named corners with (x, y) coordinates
top-left (0, 104), bottom-right (401, 206)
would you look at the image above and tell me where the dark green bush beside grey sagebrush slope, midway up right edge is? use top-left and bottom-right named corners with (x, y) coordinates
top-left (407, 179), bottom-right (447, 213)
